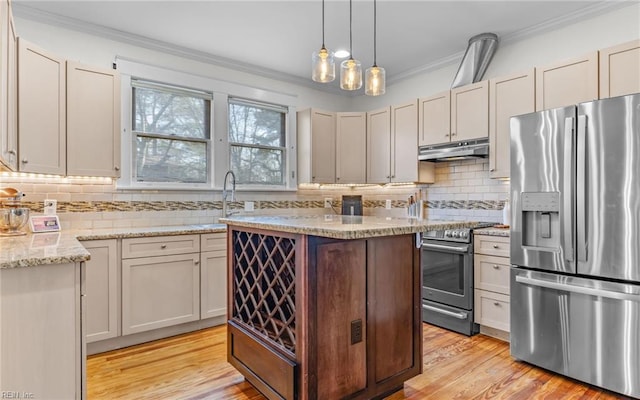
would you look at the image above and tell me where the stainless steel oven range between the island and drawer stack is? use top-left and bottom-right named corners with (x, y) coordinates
top-left (420, 229), bottom-right (479, 335)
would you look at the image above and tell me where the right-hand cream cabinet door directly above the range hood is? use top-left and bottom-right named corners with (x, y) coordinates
top-left (451, 81), bottom-right (489, 142)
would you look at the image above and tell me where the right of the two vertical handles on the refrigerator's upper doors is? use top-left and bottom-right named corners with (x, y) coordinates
top-left (576, 115), bottom-right (587, 261)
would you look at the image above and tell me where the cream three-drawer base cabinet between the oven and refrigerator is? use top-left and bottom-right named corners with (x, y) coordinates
top-left (473, 234), bottom-right (511, 340)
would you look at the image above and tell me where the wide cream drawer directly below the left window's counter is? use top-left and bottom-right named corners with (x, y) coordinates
top-left (122, 235), bottom-right (200, 259)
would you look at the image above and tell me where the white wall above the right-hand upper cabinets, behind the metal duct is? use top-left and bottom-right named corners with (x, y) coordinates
top-left (356, 2), bottom-right (640, 111)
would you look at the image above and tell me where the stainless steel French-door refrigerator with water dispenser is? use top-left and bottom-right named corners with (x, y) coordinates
top-left (510, 94), bottom-right (640, 397)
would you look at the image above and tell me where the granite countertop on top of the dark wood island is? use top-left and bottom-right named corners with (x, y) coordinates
top-left (220, 215), bottom-right (478, 239)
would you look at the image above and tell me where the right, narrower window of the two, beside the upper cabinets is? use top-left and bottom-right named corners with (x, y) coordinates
top-left (229, 98), bottom-right (288, 186)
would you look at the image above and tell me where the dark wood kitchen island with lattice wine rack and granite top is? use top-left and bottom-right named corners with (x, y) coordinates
top-left (220, 215), bottom-right (480, 399)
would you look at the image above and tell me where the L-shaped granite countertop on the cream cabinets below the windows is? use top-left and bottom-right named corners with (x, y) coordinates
top-left (0, 224), bottom-right (227, 269)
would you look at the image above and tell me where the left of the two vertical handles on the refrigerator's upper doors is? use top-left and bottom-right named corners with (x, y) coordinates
top-left (562, 117), bottom-right (575, 262)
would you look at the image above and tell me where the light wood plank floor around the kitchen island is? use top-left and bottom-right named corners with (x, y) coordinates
top-left (87, 324), bottom-right (625, 400)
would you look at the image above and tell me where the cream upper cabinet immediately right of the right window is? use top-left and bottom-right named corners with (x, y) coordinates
top-left (297, 109), bottom-right (336, 183)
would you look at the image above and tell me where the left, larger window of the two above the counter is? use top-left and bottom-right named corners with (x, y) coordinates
top-left (131, 80), bottom-right (212, 184)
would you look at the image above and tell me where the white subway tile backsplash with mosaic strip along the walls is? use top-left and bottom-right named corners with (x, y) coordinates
top-left (0, 159), bottom-right (509, 229)
